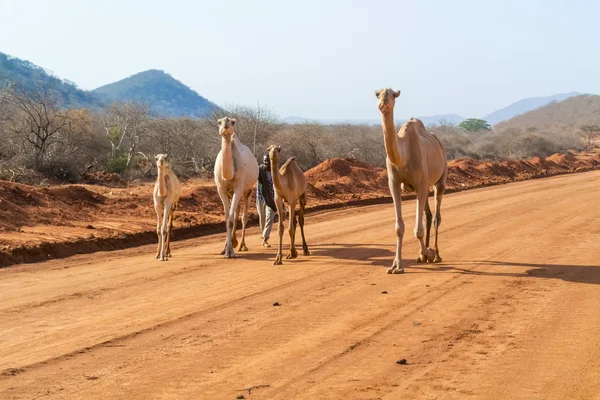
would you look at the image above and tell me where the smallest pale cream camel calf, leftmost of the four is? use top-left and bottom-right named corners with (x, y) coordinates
top-left (153, 154), bottom-right (181, 261)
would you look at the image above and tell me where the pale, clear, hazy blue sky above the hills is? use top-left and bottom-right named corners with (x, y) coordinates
top-left (0, 0), bottom-right (600, 119)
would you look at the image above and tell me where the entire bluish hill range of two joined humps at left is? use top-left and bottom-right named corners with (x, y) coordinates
top-left (0, 53), bottom-right (219, 117)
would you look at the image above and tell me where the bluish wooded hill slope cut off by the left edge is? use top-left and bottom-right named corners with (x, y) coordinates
top-left (0, 53), bottom-right (103, 109)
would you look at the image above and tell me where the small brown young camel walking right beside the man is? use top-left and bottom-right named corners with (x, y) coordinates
top-left (268, 145), bottom-right (310, 265)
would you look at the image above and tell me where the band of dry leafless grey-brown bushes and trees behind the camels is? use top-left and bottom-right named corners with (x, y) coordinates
top-left (0, 84), bottom-right (583, 183)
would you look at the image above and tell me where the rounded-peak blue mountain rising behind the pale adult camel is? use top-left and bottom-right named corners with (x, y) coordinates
top-left (91, 69), bottom-right (219, 117)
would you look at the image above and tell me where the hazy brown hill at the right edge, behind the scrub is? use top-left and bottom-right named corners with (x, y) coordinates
top-left (494, 94), bottom-right (600, 130)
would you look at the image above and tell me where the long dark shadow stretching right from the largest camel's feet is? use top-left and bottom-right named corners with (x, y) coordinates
top-left (411, 260), bottom-right (600, 285)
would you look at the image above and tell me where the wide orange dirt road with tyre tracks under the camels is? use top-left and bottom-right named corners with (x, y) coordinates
top-left (0, 172), bottom-right (600, 399)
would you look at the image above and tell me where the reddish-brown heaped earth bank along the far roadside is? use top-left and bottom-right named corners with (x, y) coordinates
top-left (0, 152), bottom-right (600, 266)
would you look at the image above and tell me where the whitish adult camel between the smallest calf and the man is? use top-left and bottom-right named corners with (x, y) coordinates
top-left (215, 117), bottom-right (258, 258)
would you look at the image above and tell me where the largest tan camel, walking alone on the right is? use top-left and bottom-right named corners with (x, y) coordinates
top-left (375, 88), bottom-right (448, 274)
